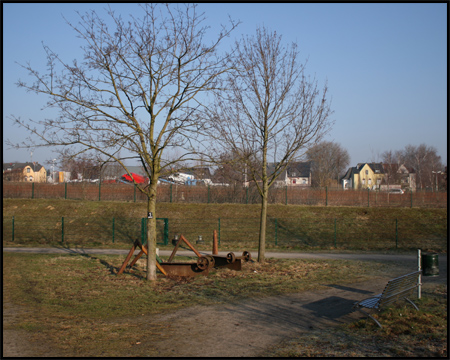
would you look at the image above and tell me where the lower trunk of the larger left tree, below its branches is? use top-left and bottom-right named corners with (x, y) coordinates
top-left (147, 182), bottom-right (157, 281)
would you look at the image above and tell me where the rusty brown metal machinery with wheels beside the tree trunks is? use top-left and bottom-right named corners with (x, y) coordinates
top-left (117, 230), bottom-right (251, 276)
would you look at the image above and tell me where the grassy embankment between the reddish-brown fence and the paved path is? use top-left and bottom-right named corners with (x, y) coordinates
top-left (3, 199), bottom-right (447, 253)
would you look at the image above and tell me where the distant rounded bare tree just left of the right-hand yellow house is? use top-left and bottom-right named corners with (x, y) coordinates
top-left (306, 141), bottom-right (350, 187)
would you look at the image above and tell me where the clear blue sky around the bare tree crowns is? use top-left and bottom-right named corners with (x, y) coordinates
top-left (2, 3), bottom-right (448, 166)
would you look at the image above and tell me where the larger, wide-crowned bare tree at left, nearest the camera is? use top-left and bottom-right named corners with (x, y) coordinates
top-left (7, 4), bottom-right (236, 280)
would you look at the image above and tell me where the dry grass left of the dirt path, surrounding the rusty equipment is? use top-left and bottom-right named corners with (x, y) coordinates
top-left (3, 253), bottom-right (404, 357)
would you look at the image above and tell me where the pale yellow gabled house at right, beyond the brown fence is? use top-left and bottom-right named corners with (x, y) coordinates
top-left (341, 163), bottom-right (385, 190)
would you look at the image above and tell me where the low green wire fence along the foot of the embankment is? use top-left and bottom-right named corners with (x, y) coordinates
top-left (3, 216), bottom-right (447, 252)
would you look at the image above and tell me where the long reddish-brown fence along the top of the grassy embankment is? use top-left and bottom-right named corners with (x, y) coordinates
top-left (3, 182), bottom-right (447, 208)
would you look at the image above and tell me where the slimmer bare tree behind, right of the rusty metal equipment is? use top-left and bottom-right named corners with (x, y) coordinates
top-left (209, 28), bottom-right (331, 262)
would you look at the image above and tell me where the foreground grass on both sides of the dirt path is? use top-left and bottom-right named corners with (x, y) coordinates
top-left (3, 253), bottom-right (447, 357)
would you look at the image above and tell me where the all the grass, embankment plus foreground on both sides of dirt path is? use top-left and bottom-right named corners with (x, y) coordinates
top-left (3, 199), bottom-right (447, 357)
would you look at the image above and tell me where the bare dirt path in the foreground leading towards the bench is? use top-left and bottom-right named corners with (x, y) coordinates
top-left (133, 278), bottom-right (385, 357)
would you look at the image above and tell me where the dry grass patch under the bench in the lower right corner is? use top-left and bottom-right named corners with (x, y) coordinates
top-left (265, 285), bottom-right (448, 358)
